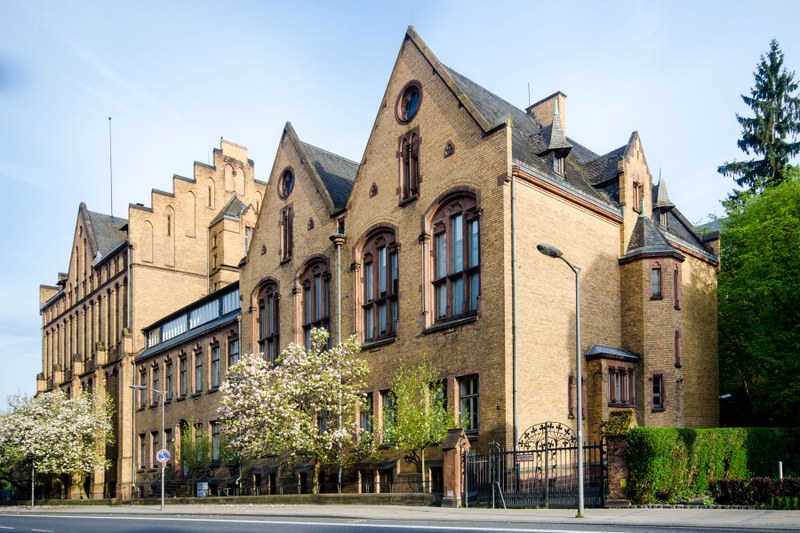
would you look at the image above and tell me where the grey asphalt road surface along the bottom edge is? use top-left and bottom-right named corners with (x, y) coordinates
top-left (0, 513), bottom-right (780, 533)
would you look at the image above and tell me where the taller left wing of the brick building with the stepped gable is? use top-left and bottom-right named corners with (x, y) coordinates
top-left (37, 140), bottom-right (265, 497)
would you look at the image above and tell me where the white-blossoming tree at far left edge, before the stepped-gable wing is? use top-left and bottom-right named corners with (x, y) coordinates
top-left (0, 391), bottom-right (113, 496)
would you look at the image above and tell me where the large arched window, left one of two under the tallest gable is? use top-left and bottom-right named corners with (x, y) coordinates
top-left (361, 231), bottom-right (399, 342)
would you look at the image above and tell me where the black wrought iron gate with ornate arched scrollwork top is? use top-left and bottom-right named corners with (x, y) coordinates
top-left (462, 422), bottom-right (608, 507)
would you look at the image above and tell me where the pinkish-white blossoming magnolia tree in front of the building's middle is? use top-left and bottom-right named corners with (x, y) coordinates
top-left (219, 329), bottom-right (372, 494)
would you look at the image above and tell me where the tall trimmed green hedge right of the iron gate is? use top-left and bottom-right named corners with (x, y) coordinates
top-left (626, 427), bottom-right (794, 503)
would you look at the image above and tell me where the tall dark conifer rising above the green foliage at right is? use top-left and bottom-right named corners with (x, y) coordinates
top-left (718, 39), bottom-right (800, 211)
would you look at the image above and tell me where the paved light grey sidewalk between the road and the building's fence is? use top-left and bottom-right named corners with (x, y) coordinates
top-left (0, 501), bottom-right (800, 531)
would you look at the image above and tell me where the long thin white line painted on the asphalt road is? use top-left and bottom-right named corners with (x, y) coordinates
top-left (0, 514), bottom-right (620, 533)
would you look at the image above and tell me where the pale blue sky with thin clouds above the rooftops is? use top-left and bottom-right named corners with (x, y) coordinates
top-left (0, 0), bottom-right (800, 404)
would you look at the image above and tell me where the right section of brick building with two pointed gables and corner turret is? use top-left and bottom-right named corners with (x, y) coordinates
top-left (241, 28), bottom-right (718, 488)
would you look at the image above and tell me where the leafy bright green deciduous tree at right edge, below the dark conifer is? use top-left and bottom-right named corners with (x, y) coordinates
top-left (718, 180), bottom-right (800, 426)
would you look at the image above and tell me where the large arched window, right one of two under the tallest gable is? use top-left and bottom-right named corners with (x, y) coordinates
top-left (433, 196), bottom-right (480, 321)
